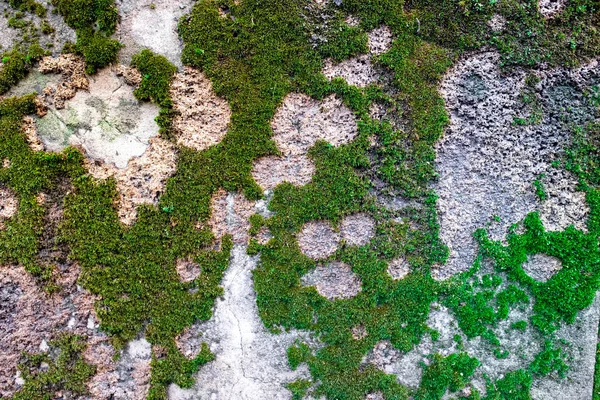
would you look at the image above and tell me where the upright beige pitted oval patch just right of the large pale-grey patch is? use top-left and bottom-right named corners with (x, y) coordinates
top-left (171, 67), bottom-right (231, 151)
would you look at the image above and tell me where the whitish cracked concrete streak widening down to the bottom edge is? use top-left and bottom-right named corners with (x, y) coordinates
top-left (168, 246), bottom-right (315, 400)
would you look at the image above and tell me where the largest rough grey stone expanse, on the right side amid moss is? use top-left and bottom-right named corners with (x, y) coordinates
top-left (434, 53), bottom-right (600, 278)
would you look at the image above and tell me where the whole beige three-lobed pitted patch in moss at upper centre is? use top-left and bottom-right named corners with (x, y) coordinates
top-left (252, 93), bottom-right (358, 189)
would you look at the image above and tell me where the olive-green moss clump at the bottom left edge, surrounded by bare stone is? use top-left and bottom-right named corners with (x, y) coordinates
top-left (12, 334), bottom-right (96, 400)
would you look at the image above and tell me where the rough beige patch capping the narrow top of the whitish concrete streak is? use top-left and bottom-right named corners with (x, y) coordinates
top-left (208, 189), bottom-right (255, 244)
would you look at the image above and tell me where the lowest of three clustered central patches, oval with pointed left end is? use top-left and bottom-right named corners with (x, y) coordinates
top-left (302, 261), bottom-right (362, 300)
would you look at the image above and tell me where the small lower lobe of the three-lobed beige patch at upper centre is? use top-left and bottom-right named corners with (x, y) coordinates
top-left (252, 155), bottom-right (315, 190)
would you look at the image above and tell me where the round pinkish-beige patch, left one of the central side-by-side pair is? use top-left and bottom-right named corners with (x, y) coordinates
top-left (298, 221), bottom-right (340, 260)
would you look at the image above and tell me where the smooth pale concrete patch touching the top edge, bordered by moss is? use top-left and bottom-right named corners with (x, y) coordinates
top-left (115, 0), bottom-right (194, 68)
